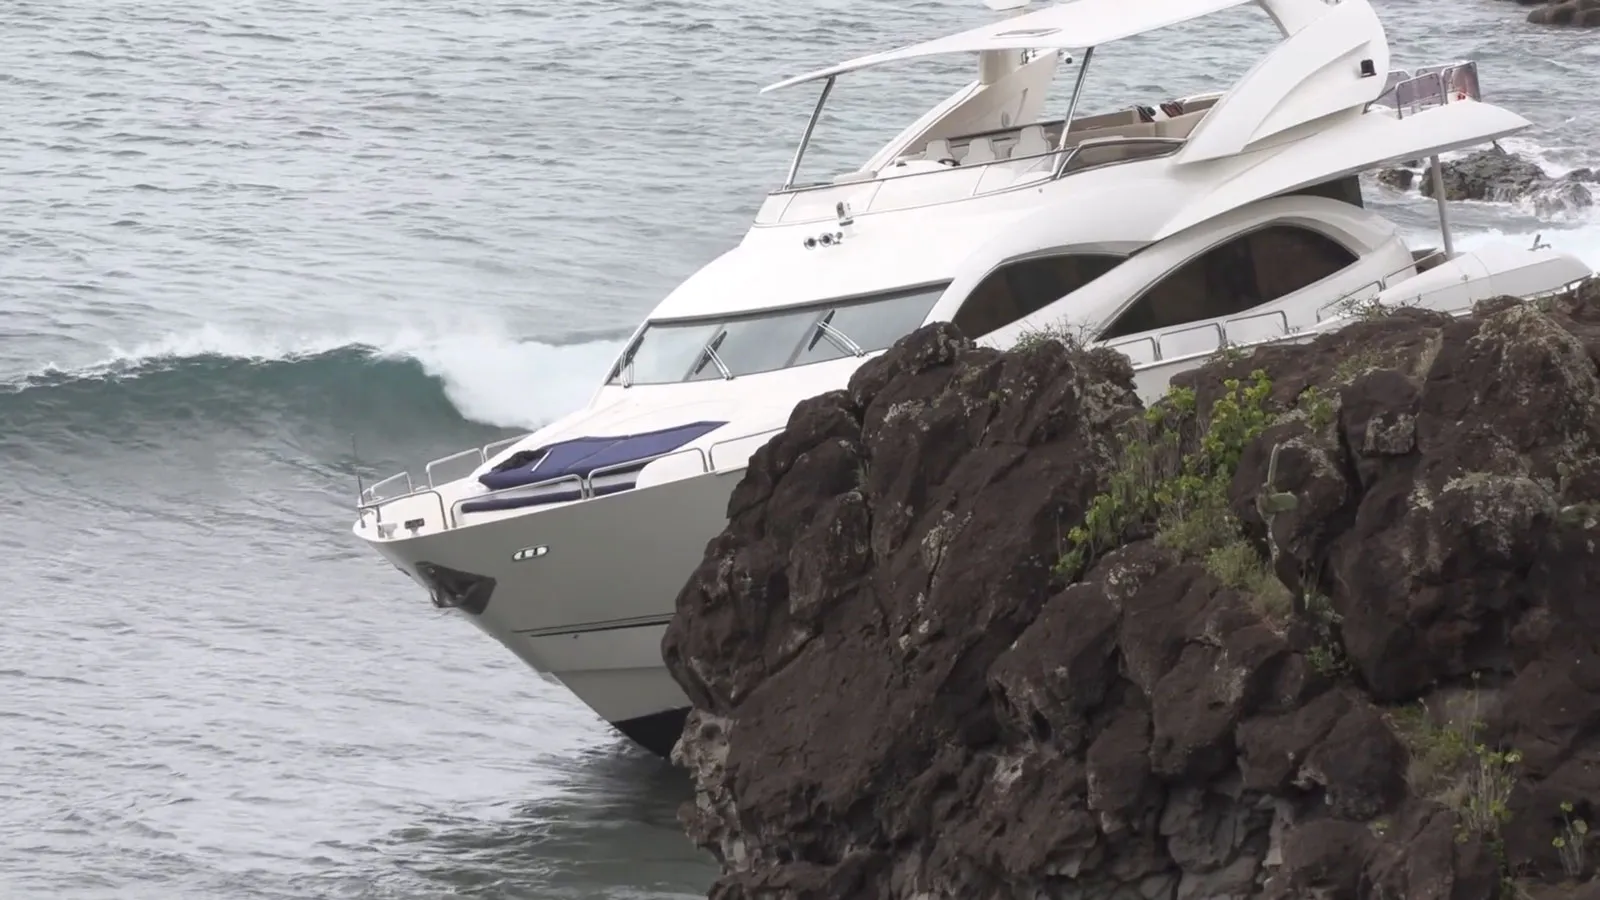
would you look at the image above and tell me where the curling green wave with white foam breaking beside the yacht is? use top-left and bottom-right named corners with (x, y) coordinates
top-left (0, 328), bottom-right (621, 440)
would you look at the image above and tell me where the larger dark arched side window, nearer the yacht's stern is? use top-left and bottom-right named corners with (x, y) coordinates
top-left (1099, 224), bottom-right (1357, 341)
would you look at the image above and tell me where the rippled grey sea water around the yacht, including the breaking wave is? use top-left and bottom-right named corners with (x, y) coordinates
top-left (0, 0), bottom-right (1600, 900)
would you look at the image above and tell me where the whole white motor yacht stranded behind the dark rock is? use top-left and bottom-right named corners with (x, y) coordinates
top-left (354, 0), bottom-right (1590, 754)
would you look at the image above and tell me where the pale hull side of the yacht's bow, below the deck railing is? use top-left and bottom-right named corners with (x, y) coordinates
top-left (357, 468), bottom-right (744, 756)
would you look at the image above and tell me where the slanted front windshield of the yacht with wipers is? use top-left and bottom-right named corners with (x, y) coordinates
top-left (606, 282), bottom-right (947, 386)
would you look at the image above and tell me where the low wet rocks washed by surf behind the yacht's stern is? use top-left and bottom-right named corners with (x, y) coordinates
top-left (1378, 148), bottom-right (1600, 216)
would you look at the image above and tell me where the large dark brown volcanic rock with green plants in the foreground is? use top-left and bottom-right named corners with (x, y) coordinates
top-left (662, 285), bottom-right (1600, 900)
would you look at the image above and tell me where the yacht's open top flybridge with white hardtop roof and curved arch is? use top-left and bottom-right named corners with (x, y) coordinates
top-left (757, 0), bottom-right (1389, 196)
